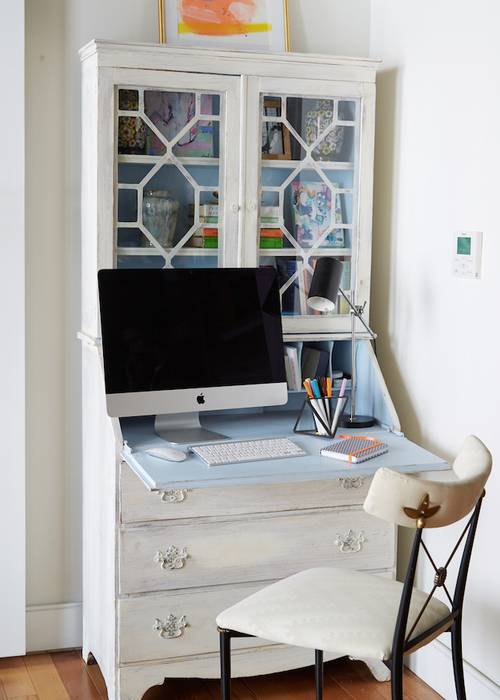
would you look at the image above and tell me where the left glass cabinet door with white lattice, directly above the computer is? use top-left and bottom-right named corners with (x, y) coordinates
top-left (114, 71), bottom-right (240, 268)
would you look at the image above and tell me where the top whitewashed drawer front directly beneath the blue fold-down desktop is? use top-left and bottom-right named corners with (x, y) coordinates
top-left (121, 464), bottom-right (372, 523)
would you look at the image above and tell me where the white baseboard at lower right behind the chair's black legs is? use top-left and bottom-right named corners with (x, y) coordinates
top-left (408, 640), bottom-right (500, 700)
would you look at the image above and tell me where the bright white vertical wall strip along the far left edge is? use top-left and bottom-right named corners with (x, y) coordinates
top-left (0, 0), bottom-right (26, 657)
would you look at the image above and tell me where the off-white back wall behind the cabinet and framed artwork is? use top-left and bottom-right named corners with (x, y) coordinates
top-left (27, 0), bottom-right (370, 649)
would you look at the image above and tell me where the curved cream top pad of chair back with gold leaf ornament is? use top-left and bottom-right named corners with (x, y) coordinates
top-left (364, 435), bottom-right (491, 528)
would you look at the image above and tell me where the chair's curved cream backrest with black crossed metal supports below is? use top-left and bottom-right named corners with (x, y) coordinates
top-left (364, 435), bottom-right (492, 669)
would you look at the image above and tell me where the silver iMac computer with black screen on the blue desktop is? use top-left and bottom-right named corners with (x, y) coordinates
top-left (98, 268), bottom-right (287, 444)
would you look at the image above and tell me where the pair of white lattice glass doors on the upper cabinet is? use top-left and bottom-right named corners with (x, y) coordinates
top-left (94, 50), bottom-right (375, 335)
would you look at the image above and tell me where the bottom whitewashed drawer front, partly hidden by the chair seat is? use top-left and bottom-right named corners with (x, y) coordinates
top-left (118, 585), bottom-right (266, 663)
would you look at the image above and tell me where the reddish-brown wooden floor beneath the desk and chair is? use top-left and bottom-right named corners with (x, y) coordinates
top-left (0, 651), bottom-right (441, 700)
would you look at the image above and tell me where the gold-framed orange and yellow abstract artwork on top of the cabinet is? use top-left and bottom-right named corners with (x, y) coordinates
top-left (158, 0), bottom-right (290, 52)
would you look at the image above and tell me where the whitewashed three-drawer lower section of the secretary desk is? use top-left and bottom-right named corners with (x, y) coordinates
top-left (117, 463), bottom-right (395, 700)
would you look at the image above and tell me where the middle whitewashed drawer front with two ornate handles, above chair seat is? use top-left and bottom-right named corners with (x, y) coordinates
top-left (120, 508), bottom-right (395, 594)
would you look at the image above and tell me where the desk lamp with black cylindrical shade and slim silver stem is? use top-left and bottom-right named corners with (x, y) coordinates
top-left (307, 258), bottom-right (377, 428)
